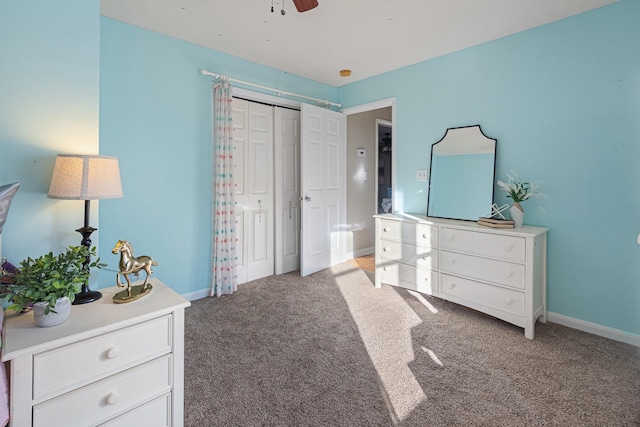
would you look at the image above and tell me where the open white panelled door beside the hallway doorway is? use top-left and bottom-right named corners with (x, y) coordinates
top-left (300, 104), bottom-right (347, 276)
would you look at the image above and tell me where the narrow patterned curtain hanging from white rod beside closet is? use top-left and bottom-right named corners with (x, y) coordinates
top-left (211, 80), bottom-right (238, 296)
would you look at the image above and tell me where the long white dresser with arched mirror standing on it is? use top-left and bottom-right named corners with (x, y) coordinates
top-left (375, 214), bottom-right (548, 339)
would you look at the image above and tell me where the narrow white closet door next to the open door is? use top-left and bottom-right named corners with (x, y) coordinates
top-left (274, 107), bottom-right (300, 274)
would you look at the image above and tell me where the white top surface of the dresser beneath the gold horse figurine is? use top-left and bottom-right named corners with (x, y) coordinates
top-left (2, 278), bottom-right (191, 361)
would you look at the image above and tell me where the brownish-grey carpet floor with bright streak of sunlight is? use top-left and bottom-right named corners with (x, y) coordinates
top-left (185, 262), bottom-right (640, 426)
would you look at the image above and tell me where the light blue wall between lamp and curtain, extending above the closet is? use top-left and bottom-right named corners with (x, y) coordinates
top-left (99, 18), bottom-right (338, 294)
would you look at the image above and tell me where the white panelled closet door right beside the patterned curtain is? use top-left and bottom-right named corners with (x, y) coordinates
top-left (233, 99), bottom-right (274, 283)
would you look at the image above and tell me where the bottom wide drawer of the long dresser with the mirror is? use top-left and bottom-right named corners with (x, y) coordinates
top-left (440, 274), bottom-right (524, 316)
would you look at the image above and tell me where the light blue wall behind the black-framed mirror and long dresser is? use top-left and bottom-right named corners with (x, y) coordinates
top-left (339, 0), bottom-right (640, 334)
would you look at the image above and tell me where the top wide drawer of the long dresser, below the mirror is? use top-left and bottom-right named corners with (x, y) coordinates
top-left (438, 227), bottom-right (525, 262)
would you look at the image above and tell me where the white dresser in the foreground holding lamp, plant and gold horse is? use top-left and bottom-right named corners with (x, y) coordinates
top-left (2, 279), bottom-right (190, 427)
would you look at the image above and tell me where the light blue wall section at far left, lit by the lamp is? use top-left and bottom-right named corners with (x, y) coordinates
top-left (0, 0), bottom-right (100, 263)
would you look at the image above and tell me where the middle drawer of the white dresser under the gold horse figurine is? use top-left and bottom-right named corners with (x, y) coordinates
top-left (33, 355), bottom-right (172, 427)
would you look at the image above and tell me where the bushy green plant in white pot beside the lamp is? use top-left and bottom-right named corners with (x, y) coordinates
top-left (1, 246), bottom-right (106, 326)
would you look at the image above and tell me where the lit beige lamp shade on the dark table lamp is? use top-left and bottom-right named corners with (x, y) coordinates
top-left (48, 154), bottom-right (123, 200)
